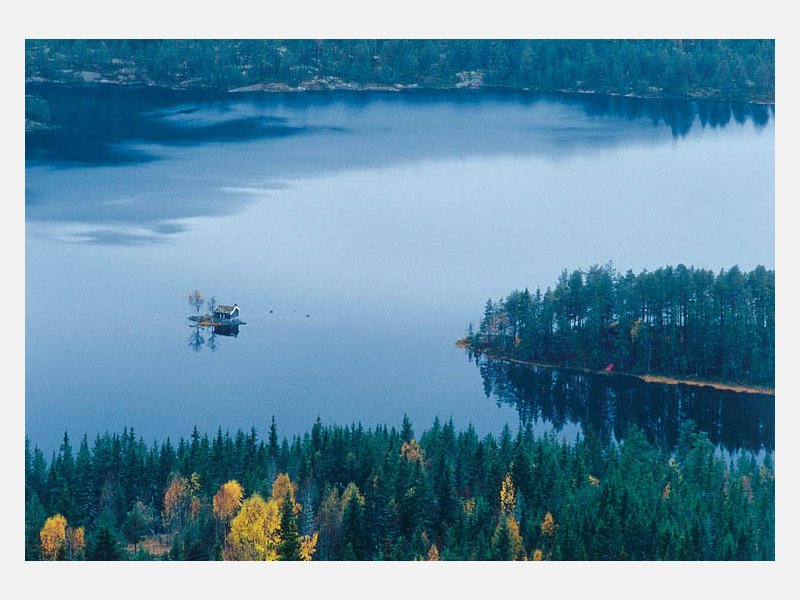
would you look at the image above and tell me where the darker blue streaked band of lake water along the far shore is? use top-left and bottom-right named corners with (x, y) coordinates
top-left (25, 84), bottom-right (774, 246)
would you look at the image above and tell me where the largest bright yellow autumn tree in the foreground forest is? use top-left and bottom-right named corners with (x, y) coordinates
top-left (224, 493), bottom-right (281, 560)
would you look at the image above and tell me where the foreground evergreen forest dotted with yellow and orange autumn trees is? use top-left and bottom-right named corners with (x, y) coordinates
top-left (25, 419), bottom-right (775, 560)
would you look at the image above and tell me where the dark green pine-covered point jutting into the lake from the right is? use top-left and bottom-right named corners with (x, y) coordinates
top-left (465, 265), bottom-right (775, 387)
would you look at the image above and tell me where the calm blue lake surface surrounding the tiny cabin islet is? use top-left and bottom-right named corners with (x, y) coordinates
top-left (25, 85), bottom-right (775, 451)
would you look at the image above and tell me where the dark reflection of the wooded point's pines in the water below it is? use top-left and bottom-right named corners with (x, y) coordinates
top-left (476, 357), bottom-right (775, 451)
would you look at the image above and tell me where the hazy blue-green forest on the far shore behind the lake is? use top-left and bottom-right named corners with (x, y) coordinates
top-left (25, 39), bottom-right (775, 102)
